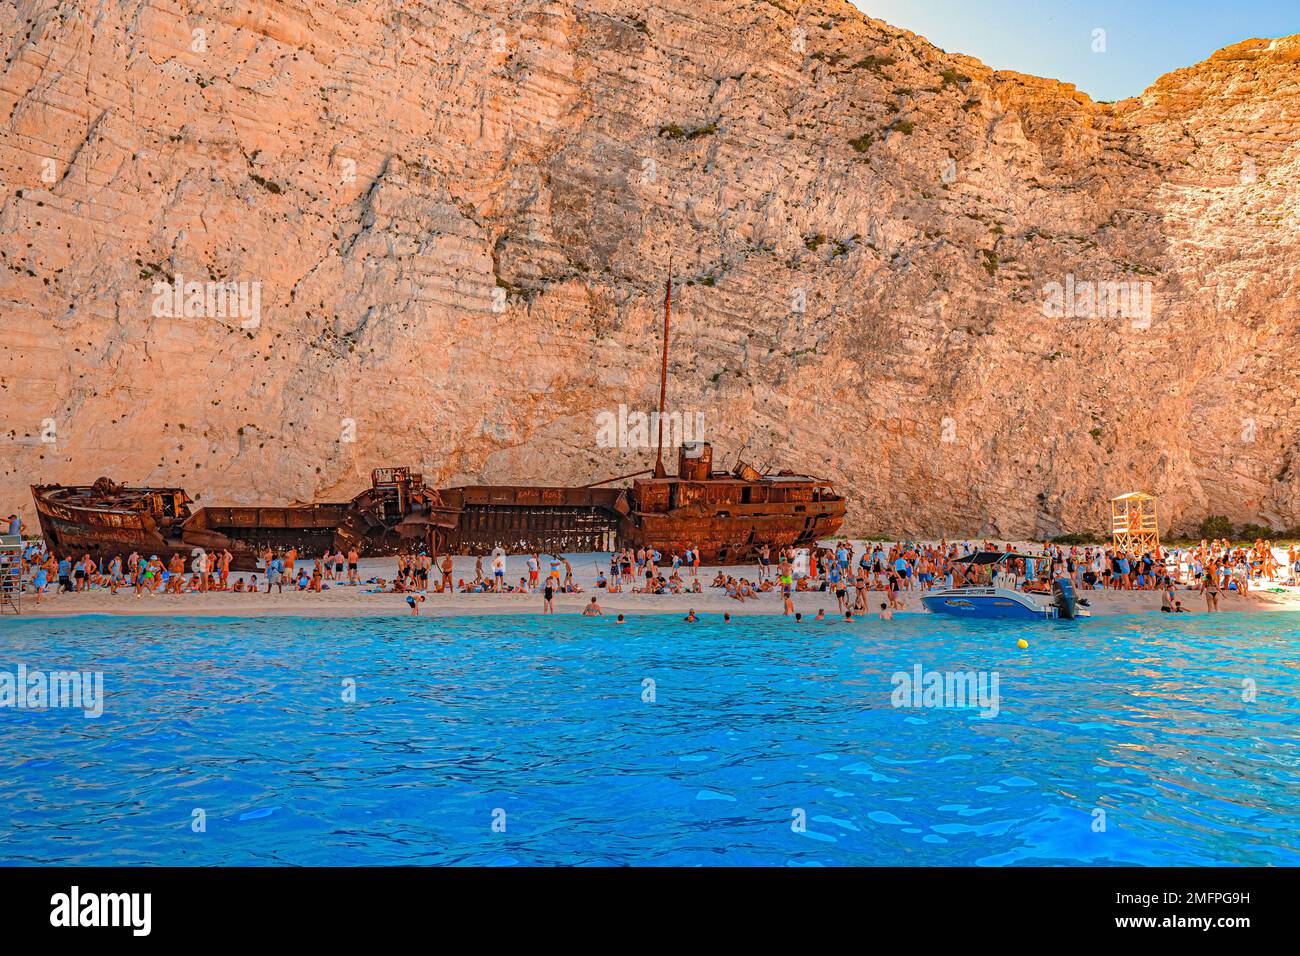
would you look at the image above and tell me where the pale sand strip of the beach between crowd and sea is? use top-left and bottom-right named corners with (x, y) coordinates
top-left (12, 545), bottom-right (1300, 618)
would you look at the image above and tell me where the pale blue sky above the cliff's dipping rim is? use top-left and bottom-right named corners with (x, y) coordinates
top-left (852, 0), bottom-right (1300, 100)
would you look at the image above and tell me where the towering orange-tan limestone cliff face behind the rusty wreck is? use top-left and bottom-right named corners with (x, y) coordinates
top-left (0, 0), bottom-right (1300, 537)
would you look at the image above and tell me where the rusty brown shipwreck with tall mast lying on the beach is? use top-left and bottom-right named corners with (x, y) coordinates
top-left (33, 276), bottom-right (845, 570)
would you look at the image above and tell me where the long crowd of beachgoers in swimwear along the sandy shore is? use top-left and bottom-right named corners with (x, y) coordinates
top-left (9, 518), bottom-right (1300, 614)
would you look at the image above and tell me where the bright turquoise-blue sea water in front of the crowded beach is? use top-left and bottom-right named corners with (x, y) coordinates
top-left (0, 614), bottom-right (1300, 865)
